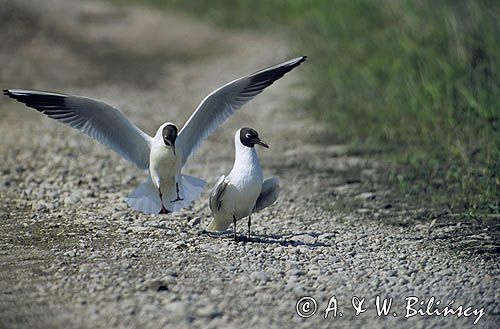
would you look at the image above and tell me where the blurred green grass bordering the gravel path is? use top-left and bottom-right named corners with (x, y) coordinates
top-left (124, 0), bottom-right (500, 216)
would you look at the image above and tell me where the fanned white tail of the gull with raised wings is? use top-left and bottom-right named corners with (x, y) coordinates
top-left (125, 175), bottom-right (205, 214)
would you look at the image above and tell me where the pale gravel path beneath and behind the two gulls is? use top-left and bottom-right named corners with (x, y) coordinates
top-left (0, 0), bottom-right (500, 328)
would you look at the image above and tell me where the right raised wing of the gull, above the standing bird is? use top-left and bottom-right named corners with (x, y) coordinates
top-left (176, 56), bottom-right (306, 164)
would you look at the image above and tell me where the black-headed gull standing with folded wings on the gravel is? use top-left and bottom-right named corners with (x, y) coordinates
top-left (207, 128), bottom-right (279, 240)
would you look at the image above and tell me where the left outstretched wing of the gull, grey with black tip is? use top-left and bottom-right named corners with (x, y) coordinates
top-left (3, 89), bottom-right (152, 169)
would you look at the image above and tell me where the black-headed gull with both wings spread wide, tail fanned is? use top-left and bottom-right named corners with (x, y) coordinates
top-left (4, 56), bottom-right (306, 214)
